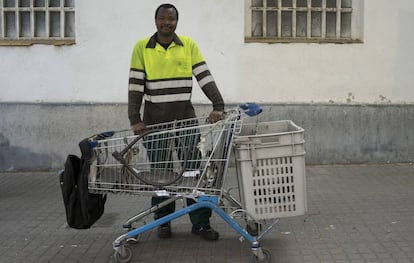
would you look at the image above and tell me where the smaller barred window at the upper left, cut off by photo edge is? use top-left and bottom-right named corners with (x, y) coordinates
top-left (0, 0), bottom-right (75, 45)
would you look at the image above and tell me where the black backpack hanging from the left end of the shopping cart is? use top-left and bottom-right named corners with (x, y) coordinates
top-left (60, 139), bottom-right (106, 229)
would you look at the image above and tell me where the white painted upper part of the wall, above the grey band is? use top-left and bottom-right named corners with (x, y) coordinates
top-left (0, 0), bottom-right (414, 103)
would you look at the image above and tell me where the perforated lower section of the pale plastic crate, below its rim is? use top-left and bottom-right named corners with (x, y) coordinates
top-left (238, 156), bottom-right (306, 220)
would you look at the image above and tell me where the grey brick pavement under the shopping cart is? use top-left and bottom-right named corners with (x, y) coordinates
top-left (0, 164), bottom-right (414, 263)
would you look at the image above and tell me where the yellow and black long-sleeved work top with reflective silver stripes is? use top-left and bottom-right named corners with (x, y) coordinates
top-left (128, 34), bottom-right (224, 124)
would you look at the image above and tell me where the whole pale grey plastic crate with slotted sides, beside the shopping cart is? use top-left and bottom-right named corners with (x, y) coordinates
top-left (234, 120), bottom-right (306, 220)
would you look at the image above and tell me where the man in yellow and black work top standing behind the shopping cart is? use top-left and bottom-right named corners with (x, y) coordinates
top-left (128, 4), bottom-right (224, 240)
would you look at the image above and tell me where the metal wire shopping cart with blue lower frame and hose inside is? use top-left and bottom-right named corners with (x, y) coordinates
top-left (88, 104), bottom-right (306, 262)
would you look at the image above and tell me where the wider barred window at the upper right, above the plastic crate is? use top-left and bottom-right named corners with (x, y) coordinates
top-left (245, 0), bottom-right (363, 43)
